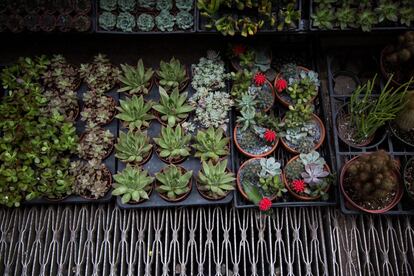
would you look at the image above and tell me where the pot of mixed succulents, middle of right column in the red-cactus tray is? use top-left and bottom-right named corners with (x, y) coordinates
top-left (279, 104), bottom-right (326, 154)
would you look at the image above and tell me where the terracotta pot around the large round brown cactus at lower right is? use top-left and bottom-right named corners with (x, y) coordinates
top-left (339, 156), bottom-right (403, 214)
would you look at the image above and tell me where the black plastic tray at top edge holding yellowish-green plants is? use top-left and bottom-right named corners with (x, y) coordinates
top-left (196, 0), bottom-right (306, 34)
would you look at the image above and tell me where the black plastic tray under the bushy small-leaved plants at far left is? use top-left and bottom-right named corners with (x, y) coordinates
top-left (22, 83), bottom-right (119, 205)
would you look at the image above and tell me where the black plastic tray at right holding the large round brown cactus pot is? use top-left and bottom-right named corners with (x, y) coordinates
top-left (327, 49), bottom-right (414, 215)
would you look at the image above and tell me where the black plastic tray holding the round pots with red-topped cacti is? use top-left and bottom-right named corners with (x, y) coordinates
top-left (233, 44), bottom-right (338, 208)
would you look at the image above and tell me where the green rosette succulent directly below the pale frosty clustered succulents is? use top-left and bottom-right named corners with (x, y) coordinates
top-left (193, 127), bottom-right (230, 162)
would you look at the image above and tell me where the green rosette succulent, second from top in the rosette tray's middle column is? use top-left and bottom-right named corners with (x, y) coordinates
top-left (152, 86), bottom-right (194, 127)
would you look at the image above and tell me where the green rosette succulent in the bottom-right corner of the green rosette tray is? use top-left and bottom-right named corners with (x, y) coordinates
top-left (197, 160), bottom-right (235, 200)
